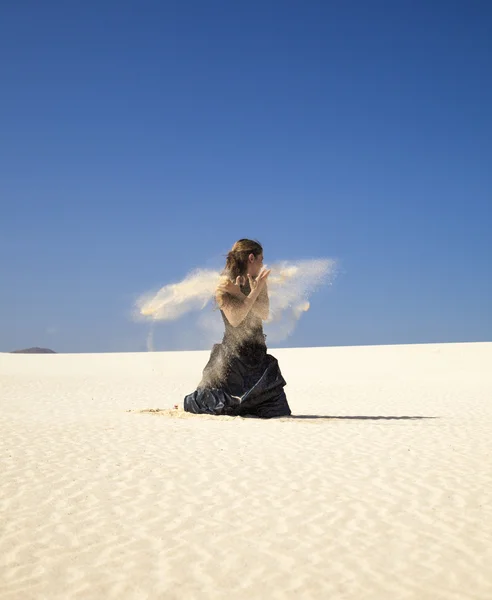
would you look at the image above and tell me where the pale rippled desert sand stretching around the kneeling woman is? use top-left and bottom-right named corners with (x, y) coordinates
top-left (0, 344), bottom-right (492, 600)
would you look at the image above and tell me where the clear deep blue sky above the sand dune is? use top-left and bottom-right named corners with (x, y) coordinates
top-left (0, 0), bottom-right (492, 352)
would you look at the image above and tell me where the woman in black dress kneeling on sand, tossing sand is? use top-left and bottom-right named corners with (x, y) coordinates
top-left (184, 239), bottom-right (290, 419)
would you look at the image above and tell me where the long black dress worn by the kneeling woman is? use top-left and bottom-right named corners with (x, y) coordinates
top-left (184, 290), bottom-right (291, 419)
